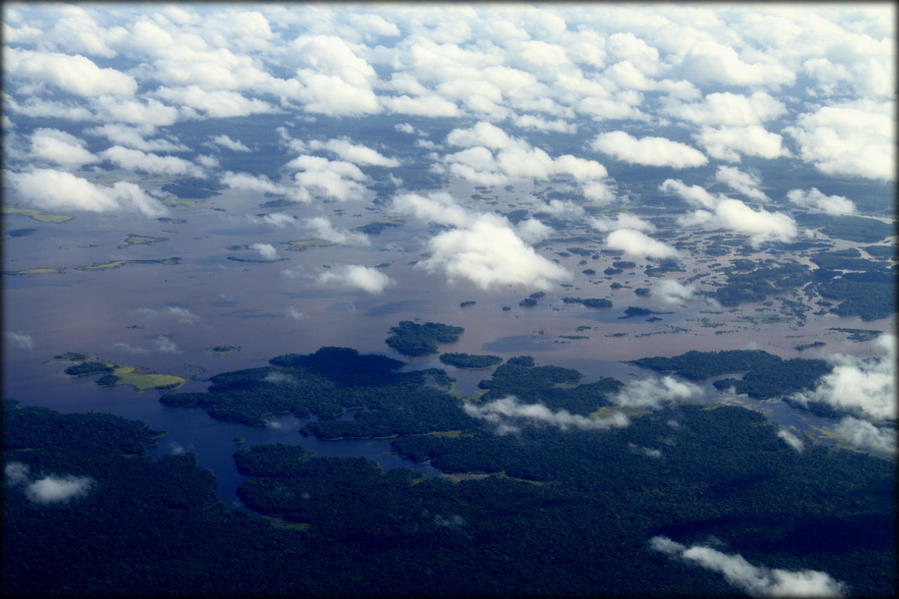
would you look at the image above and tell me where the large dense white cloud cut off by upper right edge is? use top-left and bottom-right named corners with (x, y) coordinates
top-left (784, 102), bottom-right (896, 181)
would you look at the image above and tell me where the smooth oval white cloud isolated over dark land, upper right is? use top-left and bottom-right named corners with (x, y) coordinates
top-left (591, 131), bottom-right (709, 168)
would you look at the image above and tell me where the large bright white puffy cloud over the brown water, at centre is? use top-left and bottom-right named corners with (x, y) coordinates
top-left (420, 214), bottom-right (571, 290)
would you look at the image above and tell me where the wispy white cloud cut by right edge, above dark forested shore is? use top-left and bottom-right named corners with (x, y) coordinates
top-left (793, 334), bottom-right (896, 421)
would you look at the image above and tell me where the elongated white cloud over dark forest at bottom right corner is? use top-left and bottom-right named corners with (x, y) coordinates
top-left (649, 536), bottom-right (847, 597)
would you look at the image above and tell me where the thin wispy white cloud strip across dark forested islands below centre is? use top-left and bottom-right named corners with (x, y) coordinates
top-left (462, 396), bottom-right (630, 435)
